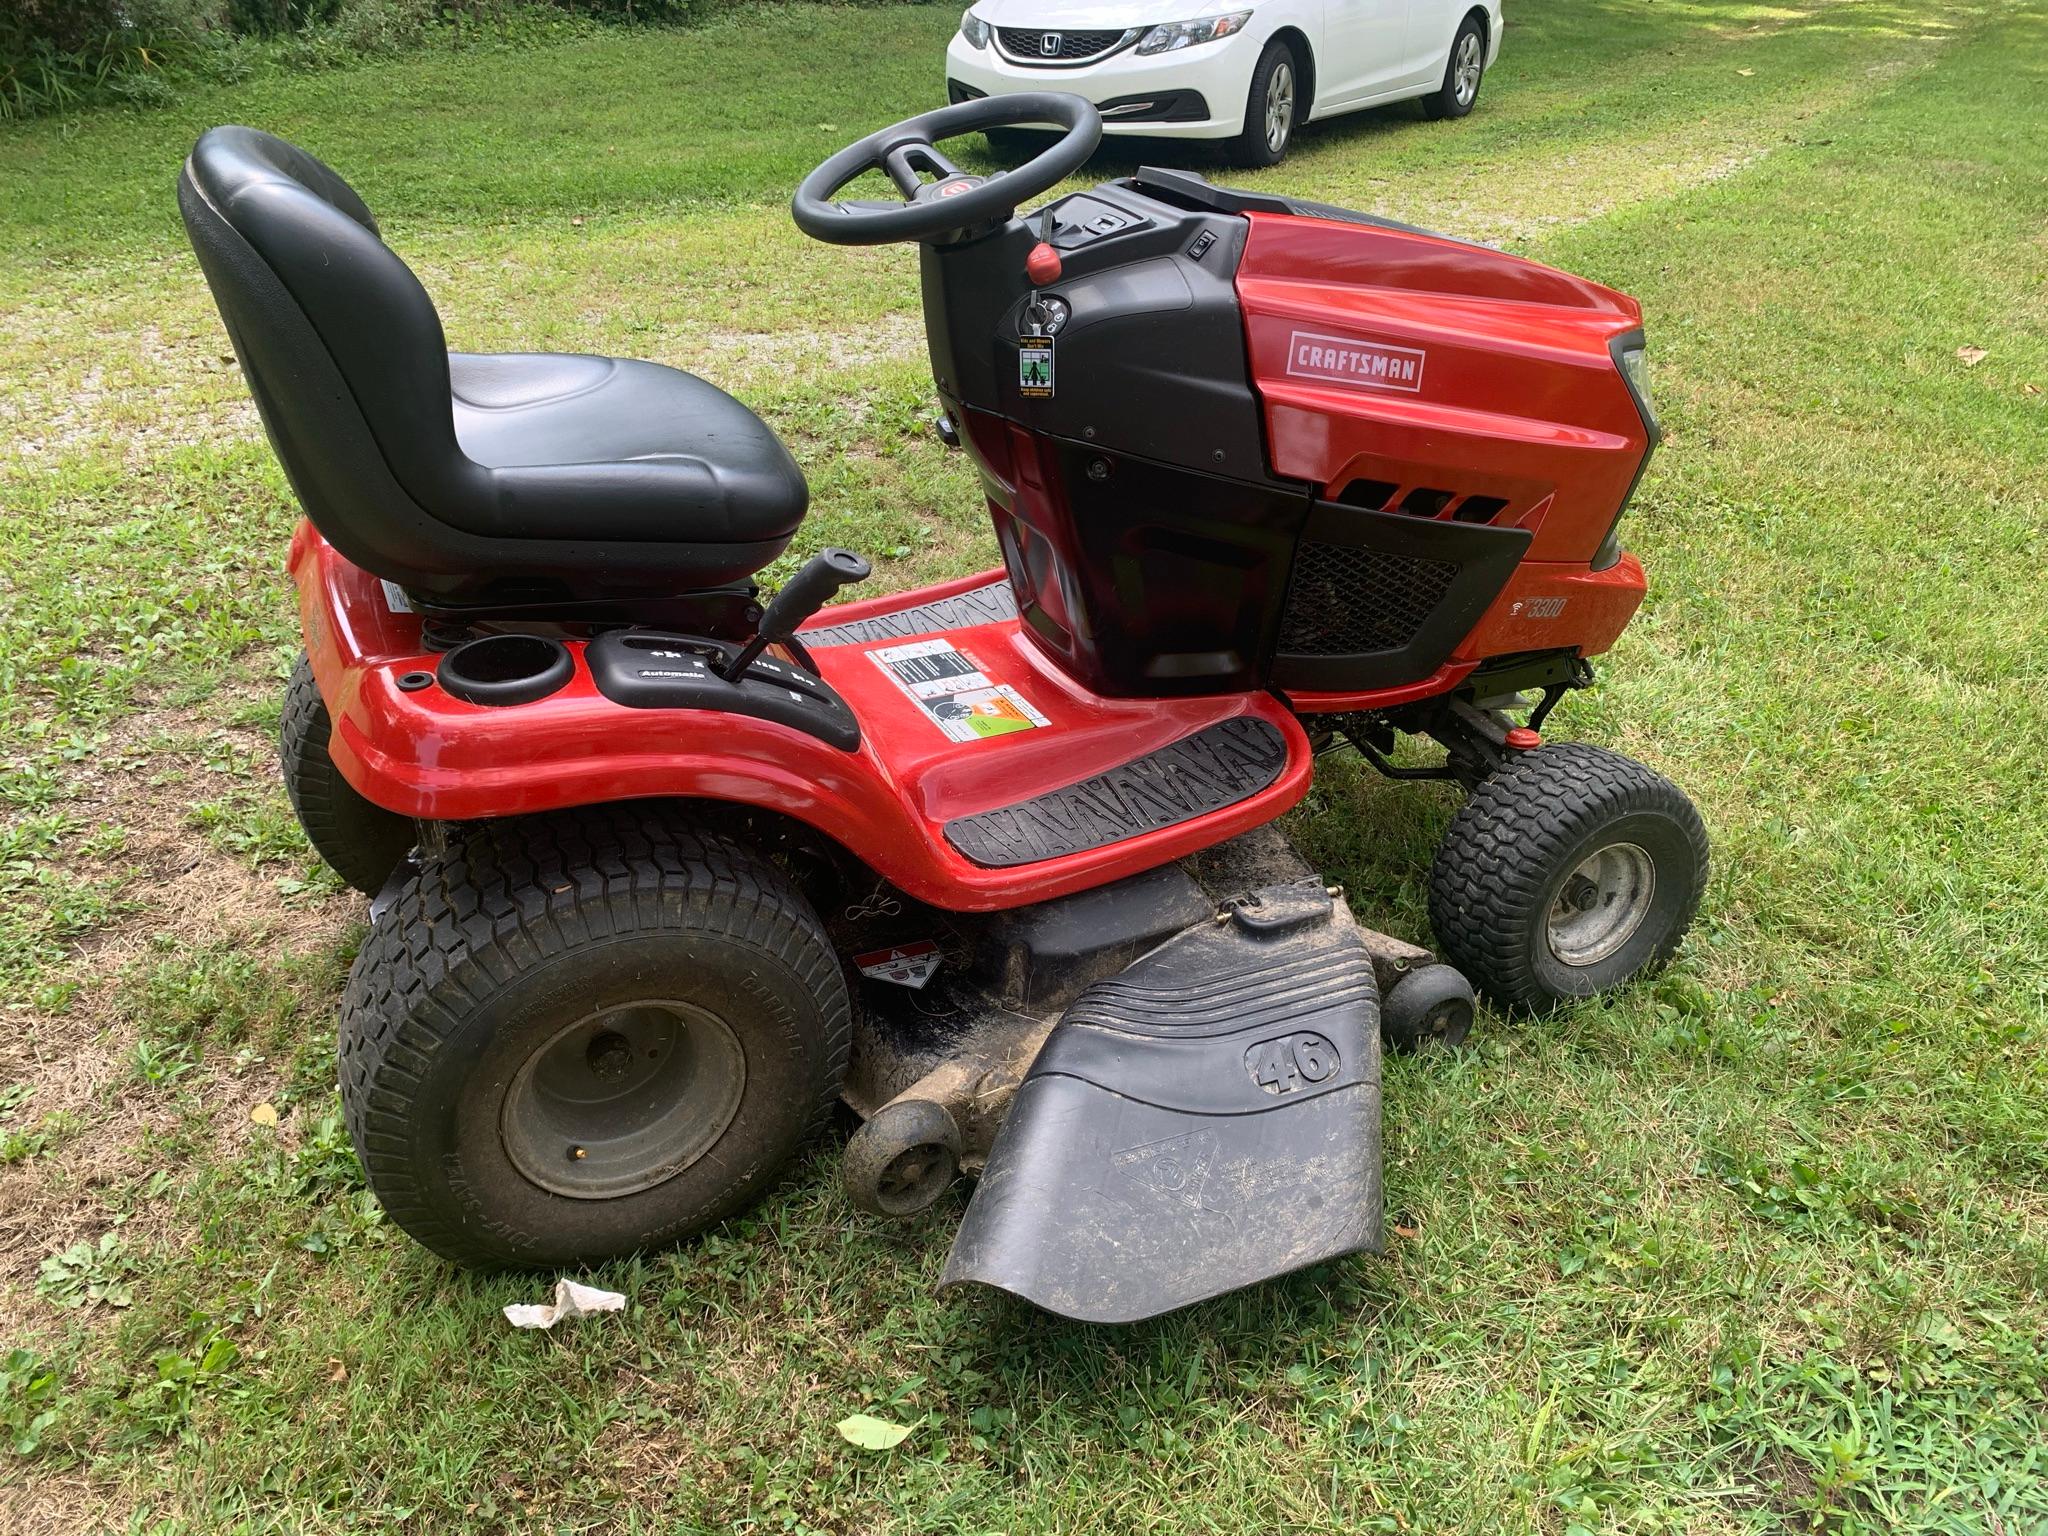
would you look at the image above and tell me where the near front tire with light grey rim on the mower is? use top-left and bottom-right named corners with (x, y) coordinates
top-left (1430, 741), bottom-right (1708, 1010)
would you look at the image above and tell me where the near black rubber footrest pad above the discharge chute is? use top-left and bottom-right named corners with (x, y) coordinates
top-left (946, 715), bottom-right (1286, 868)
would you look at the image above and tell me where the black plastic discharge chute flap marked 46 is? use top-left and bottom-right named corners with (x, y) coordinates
top-left (940, 881), bottom-right (1380, 1323)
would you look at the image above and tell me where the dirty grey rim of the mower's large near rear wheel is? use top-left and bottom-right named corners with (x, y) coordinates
top-left (498, 999), bottom-right (748, 1200)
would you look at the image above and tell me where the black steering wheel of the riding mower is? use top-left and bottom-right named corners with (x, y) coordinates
top-left (788, 90), bottom-right (1102, 246)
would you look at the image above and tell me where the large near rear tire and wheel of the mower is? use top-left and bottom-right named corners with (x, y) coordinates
top-left (340, 807), bottom-right (850, 1268)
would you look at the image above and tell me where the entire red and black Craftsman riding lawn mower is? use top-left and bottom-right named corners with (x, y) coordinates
top-left (178, 94), bottom-right (1706, 1321)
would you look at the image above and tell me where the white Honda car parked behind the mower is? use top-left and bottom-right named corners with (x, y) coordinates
top-left (946, 0), bottom-right (1501, 166)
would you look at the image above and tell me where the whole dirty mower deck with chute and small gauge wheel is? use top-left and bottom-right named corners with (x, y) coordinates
top-left (834, 827), bottom-right (1392, 1323)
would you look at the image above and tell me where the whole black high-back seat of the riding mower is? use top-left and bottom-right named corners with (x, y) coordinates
top-left (178, 127), bottom-right (809, 616)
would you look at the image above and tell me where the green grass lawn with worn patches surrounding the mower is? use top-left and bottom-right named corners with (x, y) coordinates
top-left (0, 0), bottom-right (2048, 1536)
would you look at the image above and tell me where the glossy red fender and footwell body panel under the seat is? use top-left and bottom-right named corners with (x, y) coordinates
top-left (291, 524), bottom-right (1311, 911)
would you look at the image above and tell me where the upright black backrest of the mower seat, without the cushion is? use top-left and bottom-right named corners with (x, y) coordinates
top-left (178, 127), bottom-right (489, 584)
